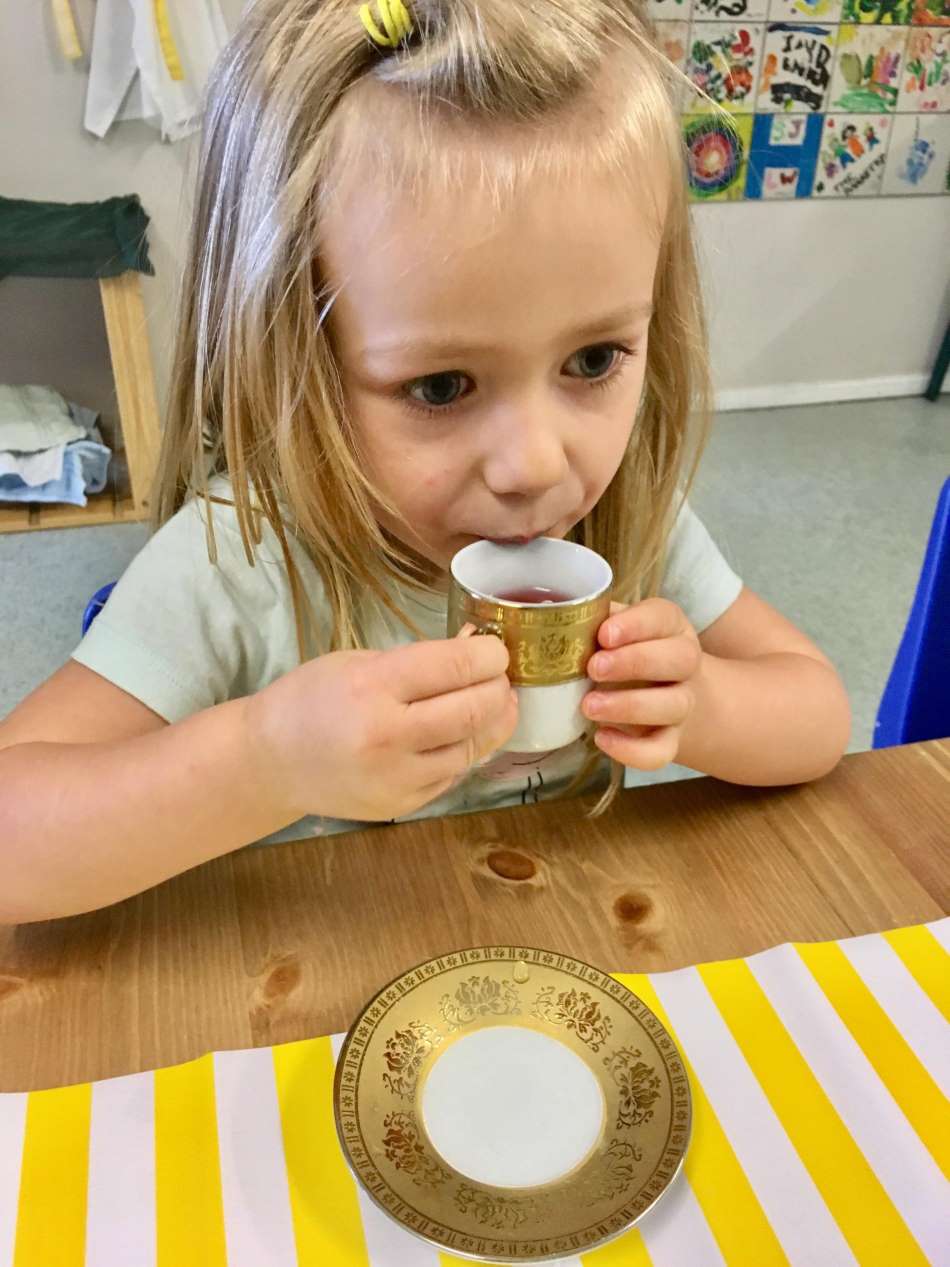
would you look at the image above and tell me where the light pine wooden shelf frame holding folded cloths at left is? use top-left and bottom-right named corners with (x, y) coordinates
top-left (0, 271), bottom-right (161, 532)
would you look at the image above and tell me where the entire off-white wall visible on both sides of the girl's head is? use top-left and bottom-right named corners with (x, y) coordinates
top-left (0, 0), bottom-right (950, 425)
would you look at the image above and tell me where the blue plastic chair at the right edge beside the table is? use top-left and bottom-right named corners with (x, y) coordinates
top-left (874, 479), bottom-right (950, 748)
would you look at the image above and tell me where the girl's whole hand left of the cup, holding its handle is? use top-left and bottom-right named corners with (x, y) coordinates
top-left (244, 635), bottom-right (518, 821)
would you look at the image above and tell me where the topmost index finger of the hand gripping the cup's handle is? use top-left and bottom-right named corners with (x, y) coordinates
top-left (376, 635), bottom-right (508, 703)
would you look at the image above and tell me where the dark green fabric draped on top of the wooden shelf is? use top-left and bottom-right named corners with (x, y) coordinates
top-left (0, 194), bottom-right (155, 277)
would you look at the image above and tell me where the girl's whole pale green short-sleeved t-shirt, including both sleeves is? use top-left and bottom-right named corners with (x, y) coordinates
top-left (72, 484), bottom-right (742, 843)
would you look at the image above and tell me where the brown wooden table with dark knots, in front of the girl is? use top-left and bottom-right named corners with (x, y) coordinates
top-left (0, 740), bottom-right (950, 1091)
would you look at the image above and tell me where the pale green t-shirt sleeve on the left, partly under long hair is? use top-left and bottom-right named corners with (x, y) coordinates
top-left (72, 502), bottom-right (301, 722)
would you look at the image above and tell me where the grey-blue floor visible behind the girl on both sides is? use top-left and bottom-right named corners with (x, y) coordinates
top-left (0, 397), bottom-right (950, 760)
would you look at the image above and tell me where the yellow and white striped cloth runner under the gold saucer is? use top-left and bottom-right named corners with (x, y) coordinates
top-left (0, 919), bottom-right (950, 1267)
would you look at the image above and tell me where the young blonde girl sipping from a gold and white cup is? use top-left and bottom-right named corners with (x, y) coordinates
top-left (0, 0), bottom-right (849, 921)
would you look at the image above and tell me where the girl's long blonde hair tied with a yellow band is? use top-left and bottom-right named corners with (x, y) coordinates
top-left (155, 0), bottom-right (709, 805)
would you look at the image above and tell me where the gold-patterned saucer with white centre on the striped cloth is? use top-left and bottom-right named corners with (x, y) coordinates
top-left (333, 946), bottom-right (692, 1262)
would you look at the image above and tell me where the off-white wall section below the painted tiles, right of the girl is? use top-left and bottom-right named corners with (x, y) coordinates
top-left (694, 196), bottom-right (950, 408)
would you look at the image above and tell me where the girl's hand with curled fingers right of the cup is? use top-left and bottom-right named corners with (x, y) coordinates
top-left (583, 598), bottom-right (703, 770)
